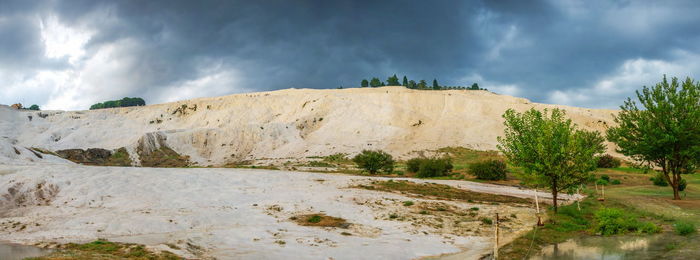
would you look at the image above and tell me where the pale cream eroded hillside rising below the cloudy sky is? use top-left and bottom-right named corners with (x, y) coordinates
top-left (0, 87), bottom-right (616, 166)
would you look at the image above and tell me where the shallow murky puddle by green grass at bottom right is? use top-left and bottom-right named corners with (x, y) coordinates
top-left (530, 234), bottom-right (672, 260)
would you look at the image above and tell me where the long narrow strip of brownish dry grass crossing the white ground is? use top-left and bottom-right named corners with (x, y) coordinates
top-left (353, 180), bottom-right (531, 204)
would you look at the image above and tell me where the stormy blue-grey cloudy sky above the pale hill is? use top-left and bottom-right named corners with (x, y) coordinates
top-left (0, 0), bottom-right (700, 110)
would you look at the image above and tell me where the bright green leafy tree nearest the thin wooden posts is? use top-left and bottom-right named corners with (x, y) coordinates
top-left (498, 108), bottom-right (605, 212)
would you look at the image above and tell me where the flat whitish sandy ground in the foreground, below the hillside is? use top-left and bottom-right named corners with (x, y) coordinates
top-left (0, 164), bottom-right (568, 259)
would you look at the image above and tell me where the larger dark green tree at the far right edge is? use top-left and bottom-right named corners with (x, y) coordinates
top-left (607, 76), bottom-right (700, 200)
